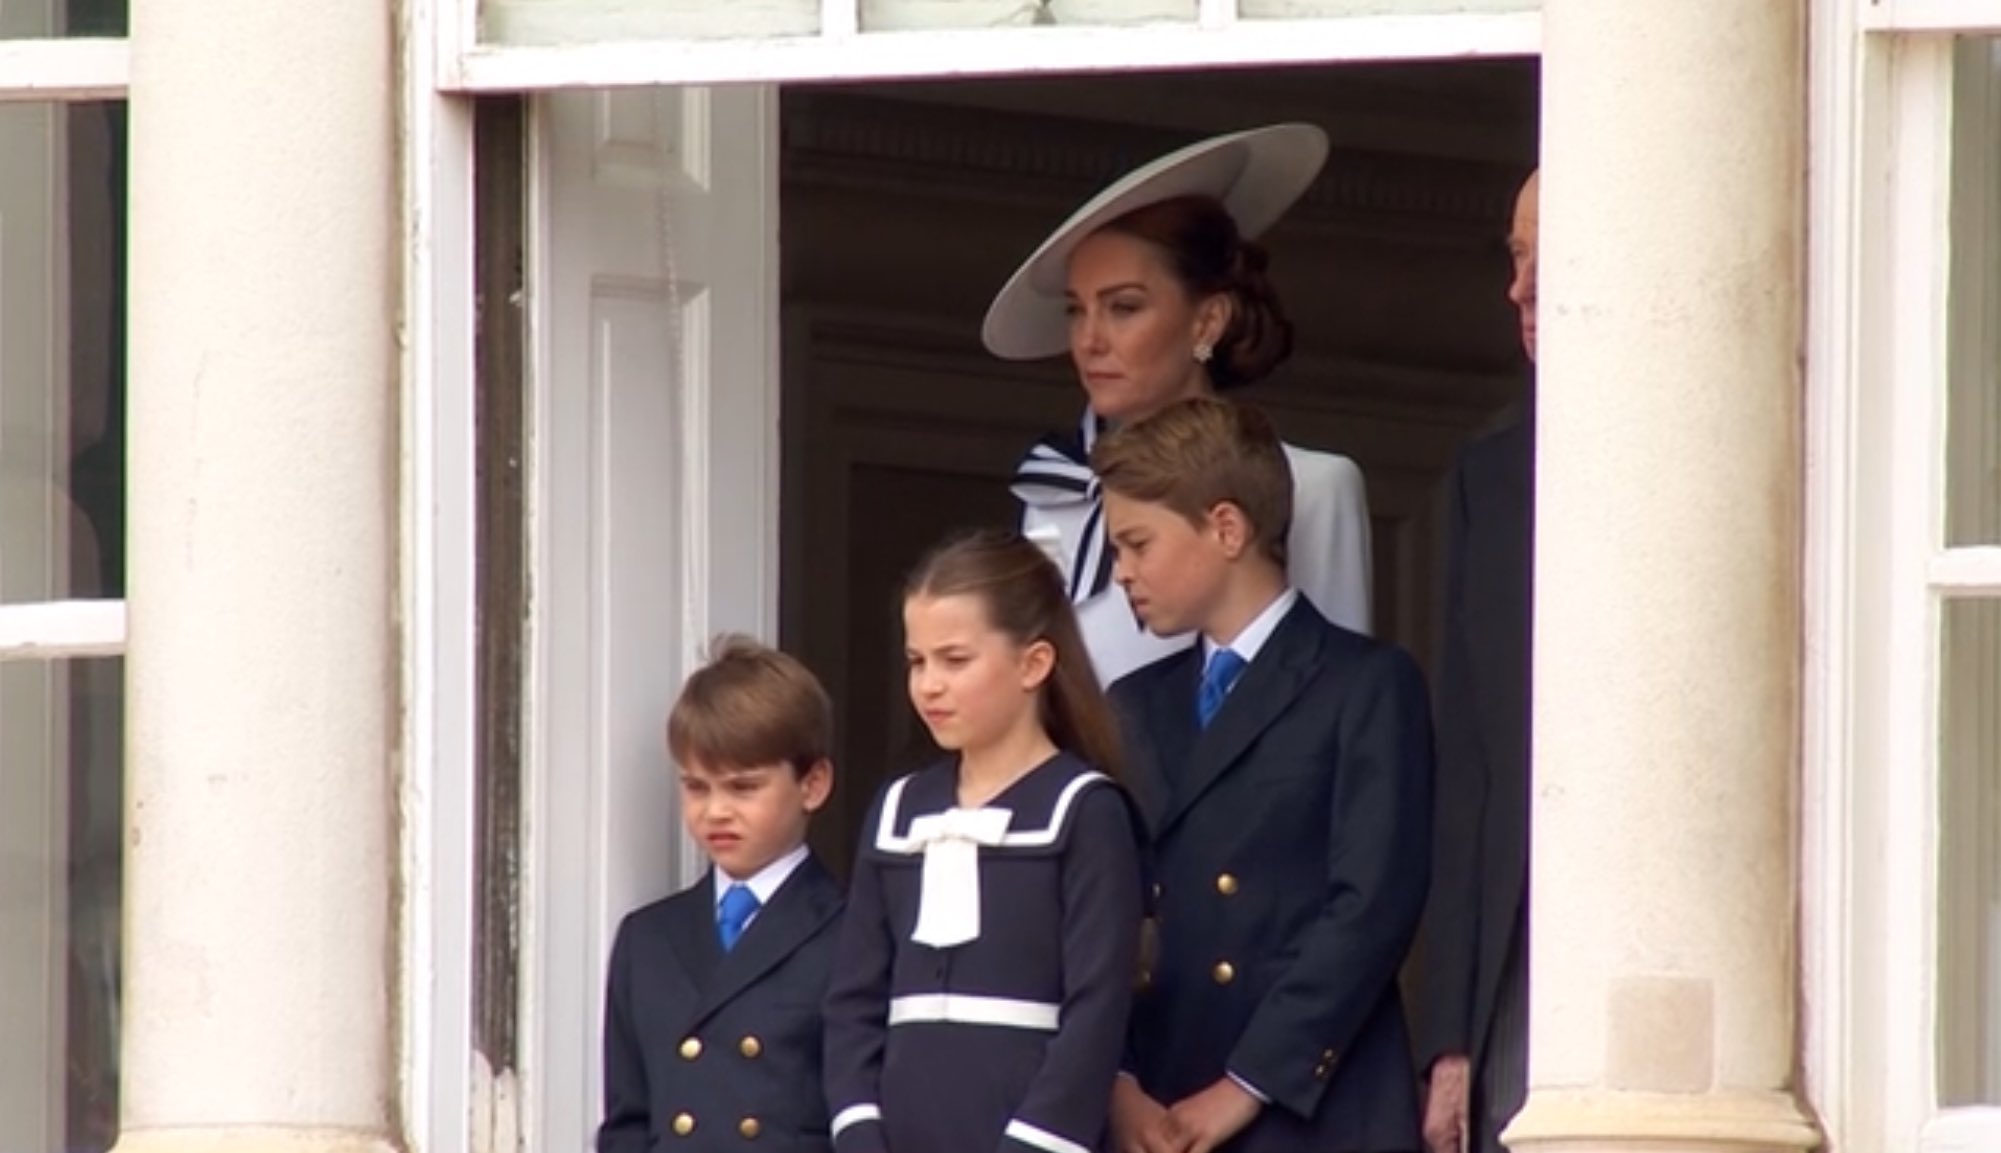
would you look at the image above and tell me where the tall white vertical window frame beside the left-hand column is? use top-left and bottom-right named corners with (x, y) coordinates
top-left (398, 0), bottom-right (478, 1153)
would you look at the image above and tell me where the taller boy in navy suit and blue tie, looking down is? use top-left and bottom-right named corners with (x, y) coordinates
top-left (1093, 398), bottom-right (1431, 1153)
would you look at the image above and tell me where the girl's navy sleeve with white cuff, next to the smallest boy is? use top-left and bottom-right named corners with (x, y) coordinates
top-left (824, 797), bottom-right (896, 1153)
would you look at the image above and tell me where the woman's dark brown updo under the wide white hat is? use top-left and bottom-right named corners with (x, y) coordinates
top-left (1105, 196), bottom-right (1293, 390)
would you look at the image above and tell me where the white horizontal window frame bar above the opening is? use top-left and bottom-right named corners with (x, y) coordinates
top-left (434, 0), bottom-right (1543, 92)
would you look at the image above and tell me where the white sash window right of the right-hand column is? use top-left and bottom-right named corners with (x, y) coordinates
top-left (1803, 0), bottom-right (2001, 1153)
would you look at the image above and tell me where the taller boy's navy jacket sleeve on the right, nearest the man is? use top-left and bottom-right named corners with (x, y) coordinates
top-left (1229, 647), bottom-right (1431, 1117)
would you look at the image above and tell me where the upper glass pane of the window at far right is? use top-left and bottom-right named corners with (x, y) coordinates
top-left (1945, 38), bottom-right (2001, 546)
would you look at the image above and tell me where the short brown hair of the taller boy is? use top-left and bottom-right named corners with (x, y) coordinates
top-left (1091, 396), bottom-right (1293, 568)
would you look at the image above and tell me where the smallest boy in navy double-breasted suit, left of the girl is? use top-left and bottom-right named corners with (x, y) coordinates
top-left (598, 637), bottom-right (842, 1153)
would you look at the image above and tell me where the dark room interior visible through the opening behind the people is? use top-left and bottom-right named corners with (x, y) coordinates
top-left (778, 60), bottom-right (1539, 871)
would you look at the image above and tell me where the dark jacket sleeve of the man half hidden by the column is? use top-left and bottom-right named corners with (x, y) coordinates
top-left (1415, 466), bottom-right (1489, 1073)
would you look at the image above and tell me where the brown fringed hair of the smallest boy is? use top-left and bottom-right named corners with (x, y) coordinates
top-left (666, 635), bottom-right (834, 775)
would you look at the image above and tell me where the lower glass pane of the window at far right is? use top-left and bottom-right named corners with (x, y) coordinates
top-left (1939, 601), bottom-right (2001, 1107)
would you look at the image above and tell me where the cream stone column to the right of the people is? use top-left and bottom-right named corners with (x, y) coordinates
top-left (1507, 0), bottom-right (1815, 1153)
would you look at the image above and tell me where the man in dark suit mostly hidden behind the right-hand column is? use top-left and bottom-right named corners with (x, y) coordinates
top-left (1419, 166), bottom-right (1537, 1153)
